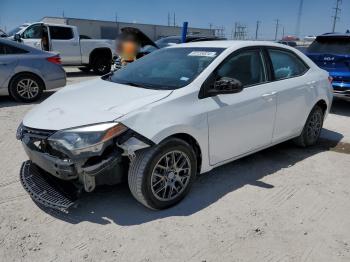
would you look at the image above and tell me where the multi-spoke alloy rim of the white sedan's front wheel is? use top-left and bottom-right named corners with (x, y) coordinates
top-left (151, 151), bottom-right (191, 201)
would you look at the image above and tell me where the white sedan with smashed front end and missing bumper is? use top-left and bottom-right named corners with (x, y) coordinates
top-left (17, 41), bottom-right (332, 210)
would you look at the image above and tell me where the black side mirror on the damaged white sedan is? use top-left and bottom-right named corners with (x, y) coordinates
top-left (207, 77), bottom-right (243, 96)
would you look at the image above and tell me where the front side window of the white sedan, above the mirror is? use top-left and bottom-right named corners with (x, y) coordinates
top-left (216, 50), bottom-right (266, 87)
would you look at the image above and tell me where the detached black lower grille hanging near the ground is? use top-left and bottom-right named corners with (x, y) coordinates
top-left (20, 161), bottom-right (77, 211)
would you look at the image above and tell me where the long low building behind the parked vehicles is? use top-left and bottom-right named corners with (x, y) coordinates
top-left (41, 17), bottom-right (215, 41)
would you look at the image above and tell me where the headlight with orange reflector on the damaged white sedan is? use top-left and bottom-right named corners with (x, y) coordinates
top-left (48, 123), bottom-right (128, 155)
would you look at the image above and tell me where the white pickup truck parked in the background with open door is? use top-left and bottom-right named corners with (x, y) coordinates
top-left (10, 22), bottom-right (115, 75)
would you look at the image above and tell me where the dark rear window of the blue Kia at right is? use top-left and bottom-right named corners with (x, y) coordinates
top-left (307, 37), bottom-right (350, 54)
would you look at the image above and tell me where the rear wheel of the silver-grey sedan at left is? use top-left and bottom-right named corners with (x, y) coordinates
top-left (9, 74), bottom-right (44, 103)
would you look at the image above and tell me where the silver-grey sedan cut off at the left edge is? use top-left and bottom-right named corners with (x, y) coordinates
top-left (0, 39), bottom-right (66, 102)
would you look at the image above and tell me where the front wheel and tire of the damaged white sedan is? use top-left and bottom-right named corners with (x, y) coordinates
top-left (128, 138), bottom-right (197, 209)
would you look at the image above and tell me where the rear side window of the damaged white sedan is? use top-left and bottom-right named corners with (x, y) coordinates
top-left (268, 49), bottom-right (309, 80)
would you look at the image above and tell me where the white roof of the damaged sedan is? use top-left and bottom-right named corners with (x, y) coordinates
top-left (168, 40), bottom-right (295, 50)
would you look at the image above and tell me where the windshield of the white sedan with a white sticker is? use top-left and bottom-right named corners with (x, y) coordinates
top-left (110, 48), bottom-right (224, 90)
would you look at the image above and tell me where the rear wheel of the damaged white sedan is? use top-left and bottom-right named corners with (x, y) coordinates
top-left (293, 105), bottom-right (324, 147)
